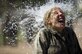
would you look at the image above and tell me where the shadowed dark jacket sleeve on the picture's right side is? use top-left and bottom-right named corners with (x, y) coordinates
top-left (68, 29), bottom-right (81, 54)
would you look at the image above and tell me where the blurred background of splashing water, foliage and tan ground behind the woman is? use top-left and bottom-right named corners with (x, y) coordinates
top-left (0, 0), bottom-right (82, 54)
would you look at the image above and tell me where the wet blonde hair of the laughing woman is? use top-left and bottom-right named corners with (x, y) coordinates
top-left (43, 7), bottom-right (63, 27)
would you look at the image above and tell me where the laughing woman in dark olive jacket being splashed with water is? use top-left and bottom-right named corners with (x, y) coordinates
top-left (35, 7), bottom-right (81, 54)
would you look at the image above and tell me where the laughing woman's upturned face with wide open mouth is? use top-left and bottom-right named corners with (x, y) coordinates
top-left (49, 9), bottom-right (65, 31)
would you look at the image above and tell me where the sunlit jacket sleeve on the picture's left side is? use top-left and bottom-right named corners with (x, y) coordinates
top-left (35, 30), bottom-right (47, 54)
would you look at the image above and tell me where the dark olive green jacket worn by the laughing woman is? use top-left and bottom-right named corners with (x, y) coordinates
top-left (35, 27), bottom-right (81, 54)
